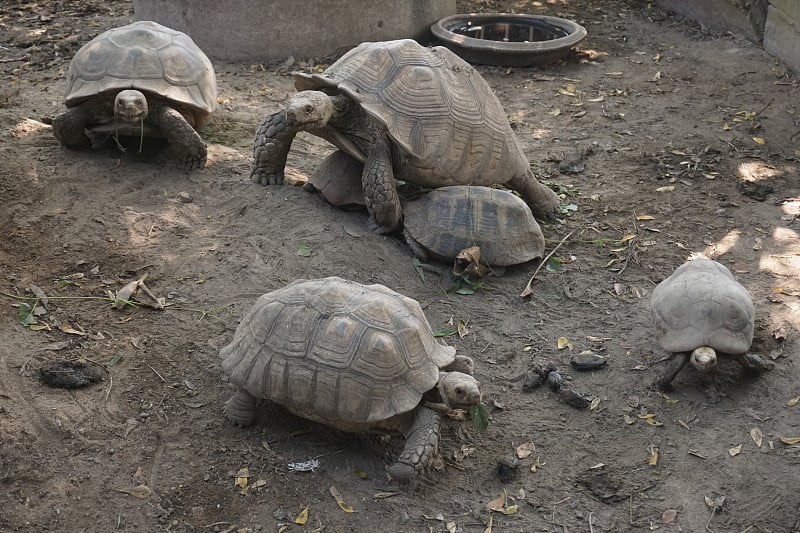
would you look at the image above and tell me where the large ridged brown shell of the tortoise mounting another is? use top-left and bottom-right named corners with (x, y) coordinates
top-left (294, 39), bottom-right (529, 187)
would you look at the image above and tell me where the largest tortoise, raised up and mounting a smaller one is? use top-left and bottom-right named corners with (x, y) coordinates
top-left (251, 39), bottom-right (560, 233)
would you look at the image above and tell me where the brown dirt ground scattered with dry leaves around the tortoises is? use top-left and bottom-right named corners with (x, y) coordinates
top-left (0, 0), bottom-right (800, 533)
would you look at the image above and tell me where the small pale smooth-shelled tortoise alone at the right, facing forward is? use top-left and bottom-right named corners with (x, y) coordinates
top-left (650, 257), bottom-right (766, 389)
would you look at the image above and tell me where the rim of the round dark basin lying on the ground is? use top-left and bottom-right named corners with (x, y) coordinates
top-left (431, 13), bottom-right (586, 67)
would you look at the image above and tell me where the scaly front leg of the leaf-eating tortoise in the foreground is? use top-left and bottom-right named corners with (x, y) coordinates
top-left (389, 406), bottom-right (442, 485)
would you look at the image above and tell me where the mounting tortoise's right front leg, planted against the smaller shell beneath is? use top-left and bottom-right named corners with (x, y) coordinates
top-left (361, 138), bottom-right (402, 233)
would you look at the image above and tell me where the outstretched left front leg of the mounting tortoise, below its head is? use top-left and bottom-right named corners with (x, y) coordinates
top-left (250, 110), bottom-right (297, 185)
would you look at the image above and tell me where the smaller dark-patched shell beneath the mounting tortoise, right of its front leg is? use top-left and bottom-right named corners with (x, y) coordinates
top-left (403, 185), bottom-right (544, 266)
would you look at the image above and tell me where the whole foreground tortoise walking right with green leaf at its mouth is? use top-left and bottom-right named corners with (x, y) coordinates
top-left (220, 277), bottom-right (481, 483)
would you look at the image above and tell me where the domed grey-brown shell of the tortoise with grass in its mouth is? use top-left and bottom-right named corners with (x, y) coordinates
top-left (65, 21), bottom-right (217, 123)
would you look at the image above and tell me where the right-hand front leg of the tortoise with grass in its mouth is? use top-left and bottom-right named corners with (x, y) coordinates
top-left (148, 103), bottom-right (208, 170)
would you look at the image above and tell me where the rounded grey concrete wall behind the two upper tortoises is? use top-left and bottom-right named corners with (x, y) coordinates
top-left (133, 0), bottom-right (456, 61)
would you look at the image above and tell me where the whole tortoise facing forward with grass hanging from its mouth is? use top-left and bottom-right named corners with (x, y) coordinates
top-left (53, 21), bottom-right (217, 170)
